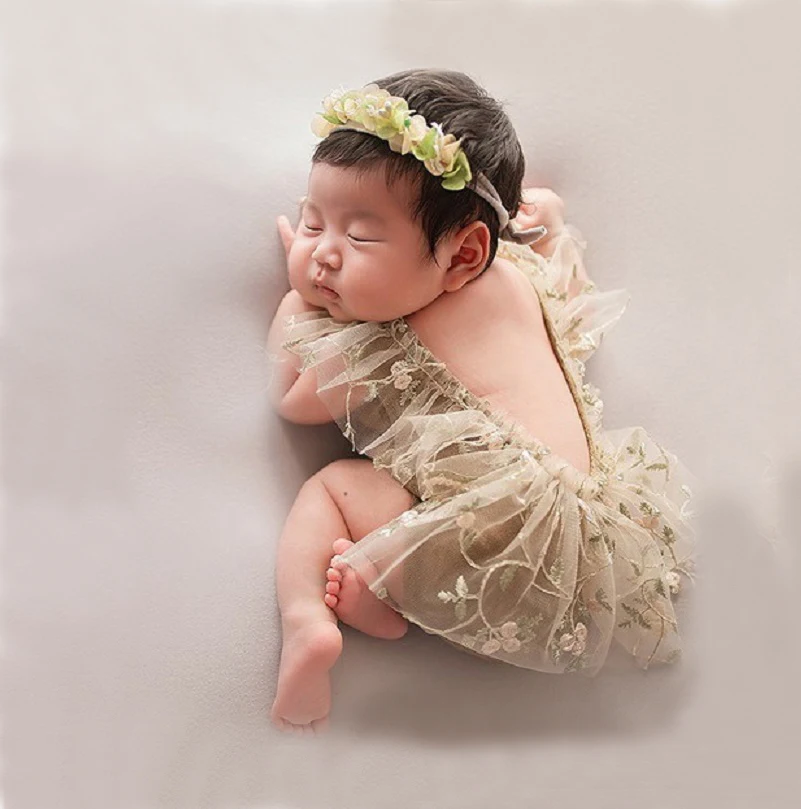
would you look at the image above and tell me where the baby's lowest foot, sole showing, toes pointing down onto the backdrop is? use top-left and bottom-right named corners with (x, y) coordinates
top-left (271, 620), bottom-right (342, 734)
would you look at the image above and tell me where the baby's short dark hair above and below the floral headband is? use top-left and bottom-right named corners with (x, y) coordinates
top-left (312, 69), bottom-right (525, 272)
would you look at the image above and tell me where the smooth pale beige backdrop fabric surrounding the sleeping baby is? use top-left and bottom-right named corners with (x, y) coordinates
top-left (2, 0), bottom-right (801, 809)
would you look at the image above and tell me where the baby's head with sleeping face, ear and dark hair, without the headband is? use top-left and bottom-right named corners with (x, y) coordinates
top-left (289, 70), bottom-right (525, 322)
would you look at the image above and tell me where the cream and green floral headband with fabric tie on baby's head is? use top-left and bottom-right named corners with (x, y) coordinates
top-left (312, 84), bottom-right (548, 244)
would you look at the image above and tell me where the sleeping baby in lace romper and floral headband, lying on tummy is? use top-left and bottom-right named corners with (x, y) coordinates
top-left (268, 70), bottom-right (694, 733)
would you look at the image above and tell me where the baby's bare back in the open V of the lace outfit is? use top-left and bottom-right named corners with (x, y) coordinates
top-left (406, 258), bottom-right (590, 473)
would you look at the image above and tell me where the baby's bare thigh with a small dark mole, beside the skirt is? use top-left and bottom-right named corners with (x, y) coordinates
top-left (317, 458), bottom-right (418, 542)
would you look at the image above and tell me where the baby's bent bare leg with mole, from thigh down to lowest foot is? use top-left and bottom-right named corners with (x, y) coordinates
top-left (272, 458), bottom-right (414, 730)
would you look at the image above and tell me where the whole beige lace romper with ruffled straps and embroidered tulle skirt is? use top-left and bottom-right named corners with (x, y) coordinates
top-left (283, 225), bottom-right (695, 676)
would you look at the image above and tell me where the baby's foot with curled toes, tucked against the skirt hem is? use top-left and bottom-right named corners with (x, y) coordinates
top-left (324, 539), bottom-right (409, 640)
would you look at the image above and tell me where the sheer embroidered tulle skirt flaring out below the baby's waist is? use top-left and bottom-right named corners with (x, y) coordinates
top-left (332, 428), bottom-right (693, 676)
